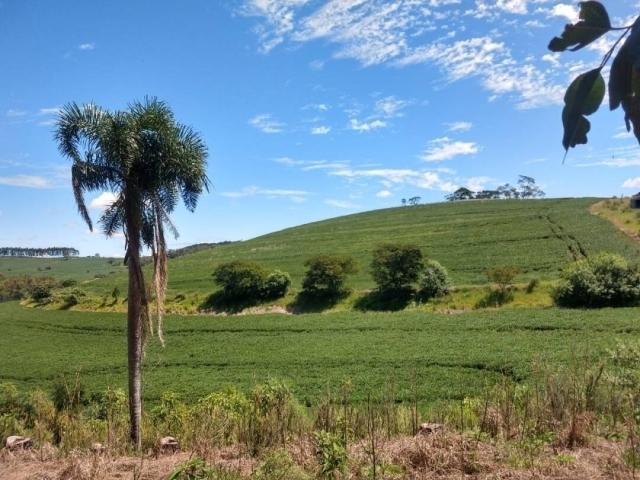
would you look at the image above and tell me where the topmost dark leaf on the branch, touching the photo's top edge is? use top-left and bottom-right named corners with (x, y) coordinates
top-left (549, 1), bottom-right (611, 52)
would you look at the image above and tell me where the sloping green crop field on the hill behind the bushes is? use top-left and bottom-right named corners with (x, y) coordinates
top-left (67, 198), bottom-right (640, 295)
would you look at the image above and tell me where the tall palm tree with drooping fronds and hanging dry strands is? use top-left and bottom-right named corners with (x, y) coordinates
top-left (55, 98), bottom-right (209, 449)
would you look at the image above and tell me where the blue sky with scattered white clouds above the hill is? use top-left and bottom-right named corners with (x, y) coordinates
top-left (0, 0), bottom-right (640, 255)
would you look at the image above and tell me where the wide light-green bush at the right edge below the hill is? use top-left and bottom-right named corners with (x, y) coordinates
top-left (553, 253), bottom-right (640, 308)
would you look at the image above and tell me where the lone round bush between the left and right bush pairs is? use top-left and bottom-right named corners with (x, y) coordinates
top-left (302, 255), bottom-right (357, 298)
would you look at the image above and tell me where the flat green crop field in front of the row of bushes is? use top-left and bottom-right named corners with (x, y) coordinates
top-left (0, 303), bottom-right (640, 404)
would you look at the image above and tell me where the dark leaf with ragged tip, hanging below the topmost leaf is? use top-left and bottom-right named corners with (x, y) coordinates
top-left (562, 68), bottom-right (605, 150)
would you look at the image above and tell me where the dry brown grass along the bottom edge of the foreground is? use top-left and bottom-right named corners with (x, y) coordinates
top-left (0, 432), bottom-right (633, 480)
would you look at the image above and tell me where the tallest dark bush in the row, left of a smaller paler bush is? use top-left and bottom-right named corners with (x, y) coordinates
top-left (371, 243), bottom-right (423, 292)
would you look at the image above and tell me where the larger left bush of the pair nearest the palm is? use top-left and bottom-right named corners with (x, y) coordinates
top-left (213, 260), bottom-right (267, 300)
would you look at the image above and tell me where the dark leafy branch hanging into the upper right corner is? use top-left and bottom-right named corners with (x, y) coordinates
top-left (549, 1), bottom-right (640, 156)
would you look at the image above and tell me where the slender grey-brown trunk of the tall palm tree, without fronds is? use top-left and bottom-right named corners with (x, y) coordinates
top-left (125, 188), bottom-right (144, 450)
